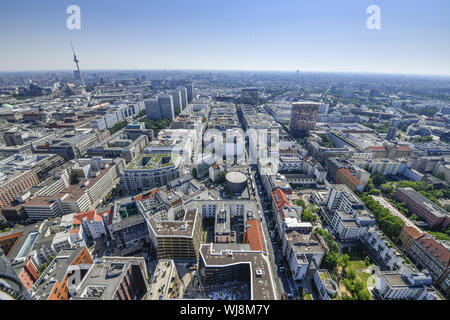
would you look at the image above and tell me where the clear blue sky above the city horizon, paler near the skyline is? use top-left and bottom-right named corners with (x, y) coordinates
top-left (0, 0), bottom-right (450, 75)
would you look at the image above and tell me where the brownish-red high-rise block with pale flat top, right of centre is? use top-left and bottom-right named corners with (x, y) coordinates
top-left (289, 101), bottom-right (321, 136)
